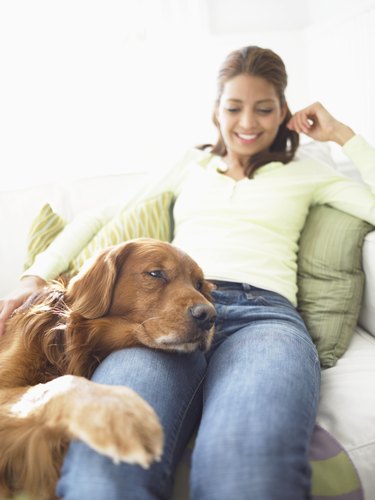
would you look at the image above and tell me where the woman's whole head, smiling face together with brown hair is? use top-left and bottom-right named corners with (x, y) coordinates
top-left (212, 47), bottom-right (299, 180)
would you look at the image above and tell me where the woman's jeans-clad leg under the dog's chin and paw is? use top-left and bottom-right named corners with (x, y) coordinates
top-left (57, 347), bottom-right (206, 500)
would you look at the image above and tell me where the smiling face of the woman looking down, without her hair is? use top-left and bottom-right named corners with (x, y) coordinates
top-left (216, 74), bottom-right (286, 163)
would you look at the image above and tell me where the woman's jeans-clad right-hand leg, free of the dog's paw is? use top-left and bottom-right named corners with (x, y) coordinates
top-left (191, 288), bottom-right (320, 500)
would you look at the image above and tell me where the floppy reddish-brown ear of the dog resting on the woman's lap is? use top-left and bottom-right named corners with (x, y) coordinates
top-left (65, 242), bottom-right (132, 319)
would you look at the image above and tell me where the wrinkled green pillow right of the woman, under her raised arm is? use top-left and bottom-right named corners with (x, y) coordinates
top-left (297, 205), bottom-right (372, 368)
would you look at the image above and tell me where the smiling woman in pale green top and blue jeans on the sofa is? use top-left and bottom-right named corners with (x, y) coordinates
top-left (0, 47), bottom-right (375, 500)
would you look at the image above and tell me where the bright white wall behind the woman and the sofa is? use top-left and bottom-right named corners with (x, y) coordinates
top-left (0, 0), bottom-right (375, 189)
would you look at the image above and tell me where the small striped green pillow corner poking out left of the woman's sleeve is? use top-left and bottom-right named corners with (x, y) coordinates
top-left (24, 203), bottom-right (65, 269)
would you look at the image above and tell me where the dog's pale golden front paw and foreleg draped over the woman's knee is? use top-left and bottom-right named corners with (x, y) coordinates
top-left (11, 375), bottom-right (163, 467)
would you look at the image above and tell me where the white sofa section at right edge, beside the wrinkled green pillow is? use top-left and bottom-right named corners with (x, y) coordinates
top-left (358, 231), bottom-right (375, 337)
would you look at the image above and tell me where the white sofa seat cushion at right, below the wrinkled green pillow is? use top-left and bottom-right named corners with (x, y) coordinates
top-left (317, 327), bottom-right (375, 500)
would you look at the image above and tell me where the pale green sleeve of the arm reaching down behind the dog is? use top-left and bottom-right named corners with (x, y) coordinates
top-left (21, 150), bottom-right (202, 280)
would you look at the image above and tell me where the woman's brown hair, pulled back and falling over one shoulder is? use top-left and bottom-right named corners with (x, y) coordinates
top-left (200, 46), bottom-right (299, 178)
